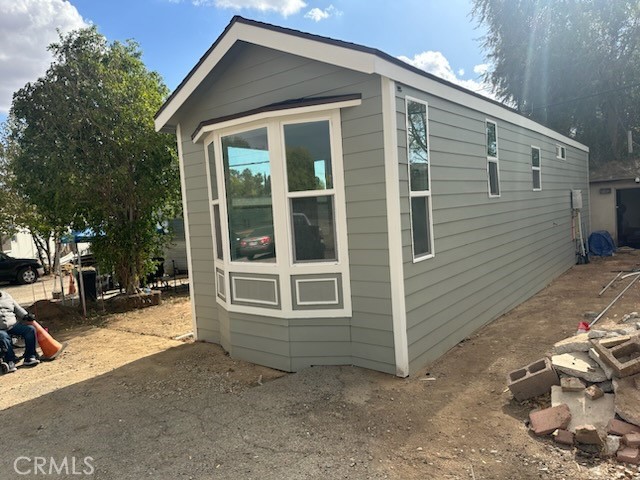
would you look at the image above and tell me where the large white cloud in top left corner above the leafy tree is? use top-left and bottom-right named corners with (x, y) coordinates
top-left (0, 0), bottom-right (87, 114)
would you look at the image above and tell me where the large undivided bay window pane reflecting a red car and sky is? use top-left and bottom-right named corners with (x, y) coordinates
top-left (222, 128), bottom-right (276, 262)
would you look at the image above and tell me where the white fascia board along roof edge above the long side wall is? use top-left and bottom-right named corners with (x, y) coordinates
top-left (375, 58), bottom-right (589, 152)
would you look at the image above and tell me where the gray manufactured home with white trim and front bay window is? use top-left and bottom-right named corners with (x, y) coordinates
top-left (155, 17), bottom-right (589, 376)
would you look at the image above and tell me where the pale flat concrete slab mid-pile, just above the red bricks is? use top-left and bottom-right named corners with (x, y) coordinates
top-left (551, 386), bottom-right (615, 432)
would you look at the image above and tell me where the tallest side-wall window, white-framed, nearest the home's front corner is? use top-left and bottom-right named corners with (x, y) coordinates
top-left (406, 98), bottom-right (434, 262)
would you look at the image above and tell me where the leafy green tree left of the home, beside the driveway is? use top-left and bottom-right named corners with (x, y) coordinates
top-left (8, 27), bottom-right (180, 293)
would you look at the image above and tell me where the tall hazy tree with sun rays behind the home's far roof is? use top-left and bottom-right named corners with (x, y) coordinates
top-left (473, 0), bottom-right (640, 163)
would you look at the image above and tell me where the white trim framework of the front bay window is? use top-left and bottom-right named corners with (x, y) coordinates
top-left (203, 107), bottom-right (352, 318)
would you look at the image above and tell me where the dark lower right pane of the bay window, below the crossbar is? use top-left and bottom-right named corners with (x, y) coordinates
top-left (291, 195), bottom-right (337, 262)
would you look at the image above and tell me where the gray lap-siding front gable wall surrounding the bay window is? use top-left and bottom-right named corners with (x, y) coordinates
top-left (175, 44), bottom-right (395, 373)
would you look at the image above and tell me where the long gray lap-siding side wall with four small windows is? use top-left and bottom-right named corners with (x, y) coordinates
top-left (396, 86), bottom-right (589, 372)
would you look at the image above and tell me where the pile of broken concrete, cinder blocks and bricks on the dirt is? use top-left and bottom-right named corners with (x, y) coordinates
top-left (507, 312), bottom-right (640, 465)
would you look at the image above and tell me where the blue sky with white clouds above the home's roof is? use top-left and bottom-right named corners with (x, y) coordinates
top-left (0, 0), bottom-right (486, 121)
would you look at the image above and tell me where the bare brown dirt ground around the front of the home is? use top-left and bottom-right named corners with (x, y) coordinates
top-left (0, 251), bottom-right (640, 480)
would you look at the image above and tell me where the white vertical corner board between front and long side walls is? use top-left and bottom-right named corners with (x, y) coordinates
top-left (382, 77), bottom-right (409, 377)
